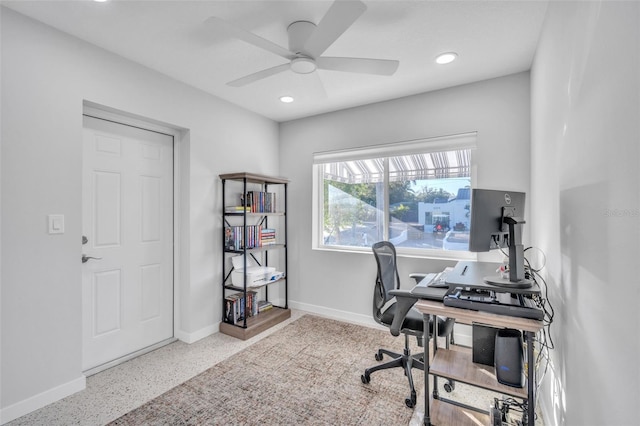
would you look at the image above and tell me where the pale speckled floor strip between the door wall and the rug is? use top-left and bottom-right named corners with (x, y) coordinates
top-left (8, 310), bottom-right (304, 426)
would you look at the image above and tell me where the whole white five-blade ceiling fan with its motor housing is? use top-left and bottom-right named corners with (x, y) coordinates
top-left (205, 0), bottom-right (399, 87)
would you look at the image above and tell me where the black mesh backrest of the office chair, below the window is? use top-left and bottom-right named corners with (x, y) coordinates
top-left (371, 241), bottom-right (400, 322)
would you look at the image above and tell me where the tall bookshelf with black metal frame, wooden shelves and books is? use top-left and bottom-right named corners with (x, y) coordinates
top-left (220, 173), bottom-right (291, 340)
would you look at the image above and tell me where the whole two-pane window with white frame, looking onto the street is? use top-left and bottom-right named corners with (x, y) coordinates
top-left (314, 133), bottom-right (476, 257)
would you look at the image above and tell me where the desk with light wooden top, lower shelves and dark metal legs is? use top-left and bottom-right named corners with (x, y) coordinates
top-left (415, 299), bottom-right (543, 426)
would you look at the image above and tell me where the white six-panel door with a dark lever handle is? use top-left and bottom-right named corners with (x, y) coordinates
top-left (78, 116), bottom-right (173, 371)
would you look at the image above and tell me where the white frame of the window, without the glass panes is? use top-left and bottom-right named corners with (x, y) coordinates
top-left (311, 132), bottom-right (477, 260)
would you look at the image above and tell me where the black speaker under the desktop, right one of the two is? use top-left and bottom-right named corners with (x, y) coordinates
top-left (495, 328), bottom-right (524, 388)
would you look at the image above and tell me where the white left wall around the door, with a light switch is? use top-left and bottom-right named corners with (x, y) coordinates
top-left (0, 8), bottom-right (279, 421)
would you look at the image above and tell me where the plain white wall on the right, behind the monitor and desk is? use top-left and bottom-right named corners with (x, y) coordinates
top-left (531, 1), bottom-right (640, 425)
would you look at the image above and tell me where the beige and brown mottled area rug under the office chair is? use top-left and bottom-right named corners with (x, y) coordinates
top-left (111, 315), bottom-right (423, 425)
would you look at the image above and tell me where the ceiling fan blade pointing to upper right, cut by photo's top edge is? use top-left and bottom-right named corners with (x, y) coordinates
top-left (304, 0), bottom-right (367, 58)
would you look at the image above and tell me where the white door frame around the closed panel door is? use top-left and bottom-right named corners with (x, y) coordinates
top-left (82, 100), bottom-right (189, 376)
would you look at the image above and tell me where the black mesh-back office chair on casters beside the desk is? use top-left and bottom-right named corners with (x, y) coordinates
top-left (361, 241), bottom-right (454, 408)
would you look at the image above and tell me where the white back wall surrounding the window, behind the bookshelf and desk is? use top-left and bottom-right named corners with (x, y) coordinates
top-left (280, 73), bottom-right (530, 322)
